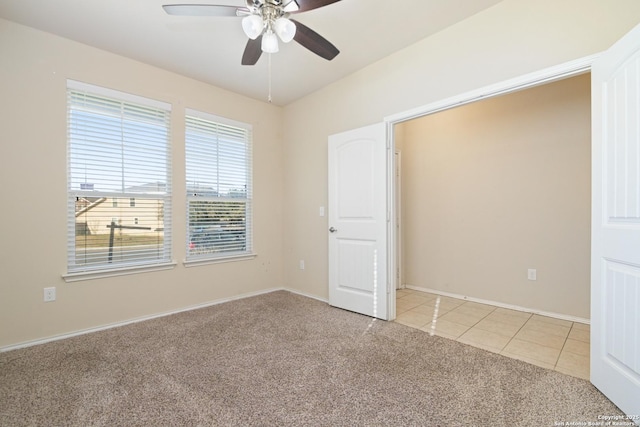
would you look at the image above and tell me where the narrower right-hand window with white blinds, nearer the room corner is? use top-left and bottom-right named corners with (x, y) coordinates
top-left (185, 110), bottom-right (252, 260)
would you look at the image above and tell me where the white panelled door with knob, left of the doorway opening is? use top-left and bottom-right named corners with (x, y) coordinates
top-left (327, 123), bottom-right (389, 320)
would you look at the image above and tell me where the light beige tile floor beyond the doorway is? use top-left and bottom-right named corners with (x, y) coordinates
top-left (395, 289), bottom-right (589, 380)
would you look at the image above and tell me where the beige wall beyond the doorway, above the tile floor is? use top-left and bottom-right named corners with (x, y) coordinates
top-left (399, 74), bottom-right (591, 319)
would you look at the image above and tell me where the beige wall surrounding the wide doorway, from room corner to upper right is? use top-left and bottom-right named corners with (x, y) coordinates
top-left (284, 0), bottom-right (640, 310)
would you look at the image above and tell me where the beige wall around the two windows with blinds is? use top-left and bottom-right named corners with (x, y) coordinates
top-left (0, 20), bottom-right (283, 347)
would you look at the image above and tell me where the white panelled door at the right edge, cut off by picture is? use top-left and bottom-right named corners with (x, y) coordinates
top-left (591, 22), bottom-right (640, 425)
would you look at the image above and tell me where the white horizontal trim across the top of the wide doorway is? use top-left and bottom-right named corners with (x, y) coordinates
top-left (384, 54), bottom-right (600, 124)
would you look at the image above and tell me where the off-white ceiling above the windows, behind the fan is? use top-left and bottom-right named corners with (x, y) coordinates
top-left (0, 0), bottom-right (501, 105)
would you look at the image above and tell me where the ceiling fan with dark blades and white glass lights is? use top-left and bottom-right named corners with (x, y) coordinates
top-left (162, 0), bottom-right (340, 65)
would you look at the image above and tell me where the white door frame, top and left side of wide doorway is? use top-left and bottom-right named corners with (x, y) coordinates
top-left (384, 53), bottom-right (601, 320)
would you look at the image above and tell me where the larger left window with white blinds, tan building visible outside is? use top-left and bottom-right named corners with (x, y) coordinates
top-left (67, 81), bottom-right (171, 275)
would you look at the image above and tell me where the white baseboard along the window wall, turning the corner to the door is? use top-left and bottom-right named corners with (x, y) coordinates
top-left (0, 287), bottom-right (320, 353)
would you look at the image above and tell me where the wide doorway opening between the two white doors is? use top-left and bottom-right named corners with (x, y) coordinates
top-left (380, 60), bottom-right (591, 379)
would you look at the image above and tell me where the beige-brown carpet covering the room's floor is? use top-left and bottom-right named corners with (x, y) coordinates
top-left (0, 291), bottom-right (622, 426)
